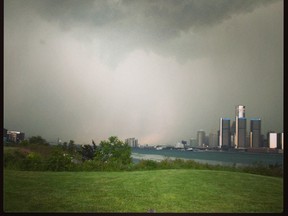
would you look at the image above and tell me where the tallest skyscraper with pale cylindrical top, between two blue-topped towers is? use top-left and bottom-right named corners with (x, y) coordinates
top-left (234, 105), bottom-right (247, 148)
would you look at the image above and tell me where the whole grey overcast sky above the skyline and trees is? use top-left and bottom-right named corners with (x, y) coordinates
top-left (4, 0), bottom-right (283, 144)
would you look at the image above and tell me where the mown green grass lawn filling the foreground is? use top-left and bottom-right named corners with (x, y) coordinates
top-left (4, 169), bottom-right (283, 213)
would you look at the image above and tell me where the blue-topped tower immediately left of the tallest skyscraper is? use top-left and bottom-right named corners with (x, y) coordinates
top-left (219, 118), bottom-right (231, 148)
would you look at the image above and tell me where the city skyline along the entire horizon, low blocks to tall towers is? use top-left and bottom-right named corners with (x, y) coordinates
top-left (3, 105), bottom-right (284, 149)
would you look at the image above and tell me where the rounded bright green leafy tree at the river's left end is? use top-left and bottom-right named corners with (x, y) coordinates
top-left (94, 136), bottom-right (132, 165)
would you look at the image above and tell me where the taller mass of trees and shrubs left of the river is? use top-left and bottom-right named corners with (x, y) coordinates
top-left (4, 136), bottom-right (132, 171)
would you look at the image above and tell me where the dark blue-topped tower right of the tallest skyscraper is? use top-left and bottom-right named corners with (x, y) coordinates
top-left (249, 118), bottom-right (261, 148)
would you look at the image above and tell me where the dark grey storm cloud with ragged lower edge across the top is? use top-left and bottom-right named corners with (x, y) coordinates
top-left (16, 0), bottom-right (277, 65)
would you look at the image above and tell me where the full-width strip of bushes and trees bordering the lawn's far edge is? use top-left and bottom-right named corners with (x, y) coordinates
top-left (3, 136), bottom-right (283, 177)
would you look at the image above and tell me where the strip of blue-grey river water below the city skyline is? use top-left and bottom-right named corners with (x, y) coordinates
top-left (132, 148), bottom-right (283, 166)
